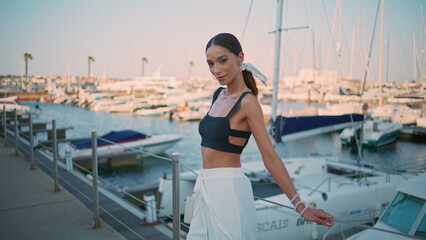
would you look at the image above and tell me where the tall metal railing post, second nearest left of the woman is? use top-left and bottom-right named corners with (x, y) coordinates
top-left (92, 131), bottom-right (101, 229)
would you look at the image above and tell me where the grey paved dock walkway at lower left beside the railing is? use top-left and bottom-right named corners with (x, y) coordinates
top-left (0, 139), bottom-right (171, 240)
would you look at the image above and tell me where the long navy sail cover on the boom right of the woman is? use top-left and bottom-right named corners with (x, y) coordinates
top-left (271, 114), bottom-right (364, 143)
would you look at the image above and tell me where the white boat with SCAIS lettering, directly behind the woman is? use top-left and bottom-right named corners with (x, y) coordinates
top-left (159, 157), bottom-right (414, 240)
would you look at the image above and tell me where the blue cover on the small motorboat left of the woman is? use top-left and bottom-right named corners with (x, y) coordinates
top-left (71, 130), bottom-right (149, 150)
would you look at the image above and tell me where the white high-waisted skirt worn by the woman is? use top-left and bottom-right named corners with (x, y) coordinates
top-left (187, 168), bottom-right (256, 240)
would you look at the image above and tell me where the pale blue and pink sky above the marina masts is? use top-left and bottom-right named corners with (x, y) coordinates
top-left (0, 0), bottom-right (426, 82)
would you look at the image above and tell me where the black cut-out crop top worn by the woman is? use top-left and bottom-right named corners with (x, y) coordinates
top-left (198, 87), bottom-right (253, 154)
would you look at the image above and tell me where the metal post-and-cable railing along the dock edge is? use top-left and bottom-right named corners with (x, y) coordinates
top-left (2, 108), bottom-right (421, 240)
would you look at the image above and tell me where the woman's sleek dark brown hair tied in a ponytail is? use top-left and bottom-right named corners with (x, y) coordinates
top-left (206, 33), bottom-right (259, 96)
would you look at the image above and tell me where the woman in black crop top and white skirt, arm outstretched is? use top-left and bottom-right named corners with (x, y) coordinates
top-left (187, 33), bottom-right (333, 240)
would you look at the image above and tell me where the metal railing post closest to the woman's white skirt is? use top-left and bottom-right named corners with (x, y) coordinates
top-left (172, 153), bottom-right (180, 240)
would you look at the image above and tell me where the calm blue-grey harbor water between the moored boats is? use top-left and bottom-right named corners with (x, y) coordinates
top-left (25, 102), bottom-right (426, 188)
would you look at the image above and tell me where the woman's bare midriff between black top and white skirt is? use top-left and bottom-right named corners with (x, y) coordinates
top-left (201, 147), bottom-right (241, 168)
